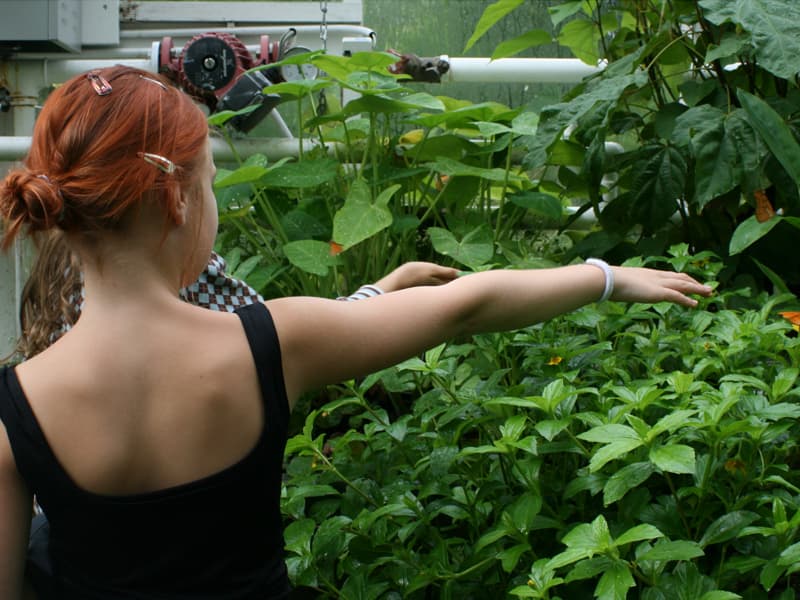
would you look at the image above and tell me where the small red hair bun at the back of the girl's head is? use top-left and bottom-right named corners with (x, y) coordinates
top-left (0, 169), bottom-right (64, 245)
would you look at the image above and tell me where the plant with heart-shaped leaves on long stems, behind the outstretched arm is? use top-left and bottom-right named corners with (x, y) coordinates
top-left (212, 52), bottom-right (563, 296)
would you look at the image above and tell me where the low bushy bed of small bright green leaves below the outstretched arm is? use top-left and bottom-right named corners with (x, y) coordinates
top-left (283, 245), bottom-right (800, 600)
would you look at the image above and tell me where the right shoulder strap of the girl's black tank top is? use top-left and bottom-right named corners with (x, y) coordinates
top-left (236, 302), bottom-right (289, 435)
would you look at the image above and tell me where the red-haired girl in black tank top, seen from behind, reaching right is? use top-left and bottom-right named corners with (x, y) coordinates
top-left (0, 66), bottom-right (711, 600)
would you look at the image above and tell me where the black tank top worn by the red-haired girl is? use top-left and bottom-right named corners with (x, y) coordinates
top-left (0, 302), bottom-right (289, 600)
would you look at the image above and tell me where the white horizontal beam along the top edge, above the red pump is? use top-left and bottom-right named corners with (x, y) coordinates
top-left (120, 0), bottom-right (363, 24)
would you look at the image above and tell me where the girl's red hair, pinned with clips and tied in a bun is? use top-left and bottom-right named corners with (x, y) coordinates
top-left (0, 66), bottom-right (208, 249)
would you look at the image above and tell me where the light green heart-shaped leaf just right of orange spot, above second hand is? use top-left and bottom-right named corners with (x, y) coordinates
top-left (333, 179), bottom-right (400, 250)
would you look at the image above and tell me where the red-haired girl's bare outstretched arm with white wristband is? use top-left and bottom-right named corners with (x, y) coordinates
top-left (268, 264), bottom-right (711, 402)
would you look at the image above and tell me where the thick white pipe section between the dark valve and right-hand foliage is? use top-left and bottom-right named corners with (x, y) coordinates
top-left (441, 56), bottom-right (601, 83)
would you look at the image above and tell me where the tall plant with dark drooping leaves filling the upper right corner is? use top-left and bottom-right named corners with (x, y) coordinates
top-left (471, 0), bottom-right (800, 286)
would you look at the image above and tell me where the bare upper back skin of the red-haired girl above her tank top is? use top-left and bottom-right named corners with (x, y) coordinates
top-left (17, 299), bottom-right (264, 495)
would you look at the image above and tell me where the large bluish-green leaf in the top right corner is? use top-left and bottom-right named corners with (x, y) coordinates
top-left (699, 0), bottom-right (800, 79)
